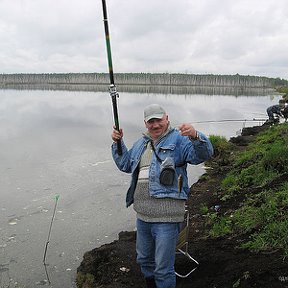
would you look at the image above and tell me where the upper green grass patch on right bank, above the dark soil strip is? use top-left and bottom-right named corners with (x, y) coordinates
top-left (222, 123), bottom-right (288, 198)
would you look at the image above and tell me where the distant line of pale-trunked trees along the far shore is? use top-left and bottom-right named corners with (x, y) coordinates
top-left (0, 73), bottom-right (288, 88)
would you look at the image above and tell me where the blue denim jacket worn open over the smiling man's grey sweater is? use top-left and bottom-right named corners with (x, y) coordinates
top-left (112, 129), bottom-right (213, 207)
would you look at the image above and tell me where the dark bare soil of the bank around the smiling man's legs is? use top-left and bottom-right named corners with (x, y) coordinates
top-left (77, 126), bottom-right (288, 288)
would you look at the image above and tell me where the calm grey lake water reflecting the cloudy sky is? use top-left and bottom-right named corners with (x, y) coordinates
top-left (0, 90), bottom-right (280, 287)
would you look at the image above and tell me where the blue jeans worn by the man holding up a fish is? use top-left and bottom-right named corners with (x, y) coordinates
top-left (136, 219), bottom-right (180, 288)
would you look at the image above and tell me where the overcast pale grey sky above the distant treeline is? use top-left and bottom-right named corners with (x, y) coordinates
top-left (0, 0), bottom-right (288, 79)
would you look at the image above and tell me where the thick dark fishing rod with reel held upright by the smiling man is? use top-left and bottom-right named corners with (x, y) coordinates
top-left (102, 0), bottom-right (122, 155)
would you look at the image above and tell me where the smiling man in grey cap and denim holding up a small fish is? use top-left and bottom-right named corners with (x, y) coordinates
top-left (112, 104), bottom-right (213, 288)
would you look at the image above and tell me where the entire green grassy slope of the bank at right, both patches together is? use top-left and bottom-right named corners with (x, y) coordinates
top-left (208, 123), bottom-right (288, 258)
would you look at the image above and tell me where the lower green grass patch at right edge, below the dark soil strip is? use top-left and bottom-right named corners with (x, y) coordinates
top-left (210, 183), bottom-right (288, 257)
